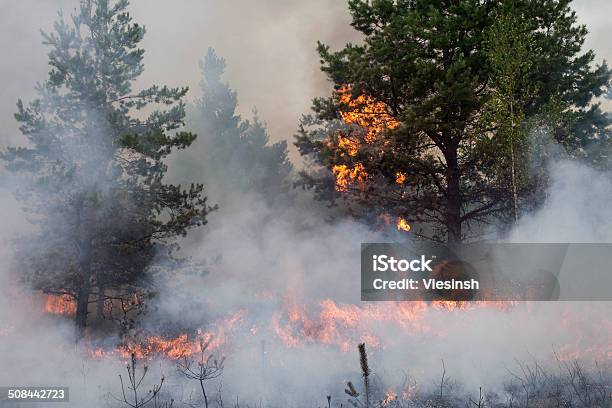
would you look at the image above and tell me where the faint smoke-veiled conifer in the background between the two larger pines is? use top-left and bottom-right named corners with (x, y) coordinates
top-left (177, 48), bottom-right (292, 207)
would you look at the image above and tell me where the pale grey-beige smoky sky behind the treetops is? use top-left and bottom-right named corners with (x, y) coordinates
top-left (0, 0), bottom-right (612, 158)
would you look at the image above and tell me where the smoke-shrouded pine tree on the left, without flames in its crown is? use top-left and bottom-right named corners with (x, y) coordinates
top-left (2, 0), bottom-right (209, 333)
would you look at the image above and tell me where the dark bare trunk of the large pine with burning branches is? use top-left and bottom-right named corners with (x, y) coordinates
top-left (444, 146), bottom-right (461, 244)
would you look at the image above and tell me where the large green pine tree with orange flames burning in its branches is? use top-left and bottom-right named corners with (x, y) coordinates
top-left (296, 0), bottom-right (610, 242)
